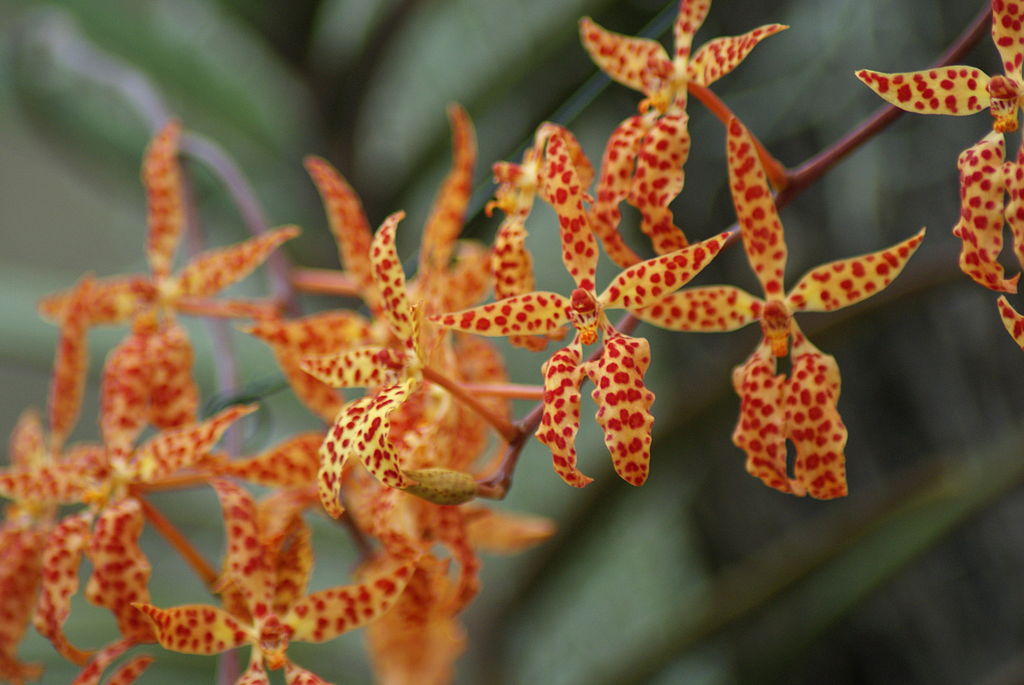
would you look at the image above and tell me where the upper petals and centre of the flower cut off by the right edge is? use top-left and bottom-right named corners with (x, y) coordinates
top-left (857, 0), bottom-right (1024, 133)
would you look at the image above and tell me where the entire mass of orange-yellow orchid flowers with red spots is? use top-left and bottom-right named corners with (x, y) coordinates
top-left (0, 0), bottom-right (983, 684)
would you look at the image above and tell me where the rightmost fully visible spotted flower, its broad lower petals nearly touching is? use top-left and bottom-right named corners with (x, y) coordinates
top-left (638, 120), bottom-right (925, 499)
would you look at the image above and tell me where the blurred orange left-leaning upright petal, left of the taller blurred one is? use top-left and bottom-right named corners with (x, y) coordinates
top-left (305, 157), bottom-right (376, 301)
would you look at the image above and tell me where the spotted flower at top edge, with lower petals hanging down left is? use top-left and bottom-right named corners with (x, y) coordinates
top-left (580, 0), bottom-right (786, 267)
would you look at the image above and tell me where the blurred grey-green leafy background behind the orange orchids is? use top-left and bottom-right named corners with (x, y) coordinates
top-left (0, 0), bottom-right (1024, 685)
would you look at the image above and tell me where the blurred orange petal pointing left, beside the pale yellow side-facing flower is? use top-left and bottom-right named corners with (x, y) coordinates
top-left (215, 431), bottom-right (324, 487)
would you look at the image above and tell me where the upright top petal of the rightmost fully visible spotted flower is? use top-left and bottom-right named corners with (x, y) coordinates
top-left (726, 119), bottom-right (786, 298)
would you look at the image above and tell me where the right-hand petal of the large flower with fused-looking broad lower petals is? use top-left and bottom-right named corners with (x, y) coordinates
top-left (785, 228), bottom-right (925, 311)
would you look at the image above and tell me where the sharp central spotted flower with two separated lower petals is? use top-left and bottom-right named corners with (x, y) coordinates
top-left (431, 134), bottom-right (725, 487)
